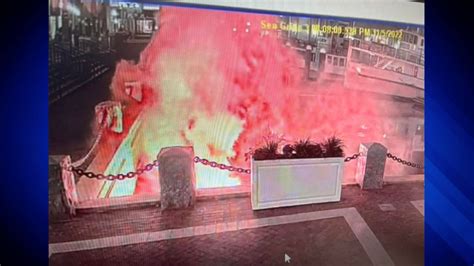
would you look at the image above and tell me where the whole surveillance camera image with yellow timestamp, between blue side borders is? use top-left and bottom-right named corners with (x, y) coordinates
top-left (48, 0), bottom-right (425, 265)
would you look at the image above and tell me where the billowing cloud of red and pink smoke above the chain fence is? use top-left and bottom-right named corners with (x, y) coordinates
top-left (111, 7), bottom-right (410, 183)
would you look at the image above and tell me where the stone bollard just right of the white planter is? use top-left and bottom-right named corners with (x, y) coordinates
top-left (355, 143), bottom-right (387, 189)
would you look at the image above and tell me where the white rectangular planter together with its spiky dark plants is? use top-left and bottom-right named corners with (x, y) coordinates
top-left (251, 137), bottom-right (344, 210)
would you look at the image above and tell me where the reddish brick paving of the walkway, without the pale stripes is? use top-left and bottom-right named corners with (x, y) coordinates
top-left (50, 182), bottom-right (424, 265)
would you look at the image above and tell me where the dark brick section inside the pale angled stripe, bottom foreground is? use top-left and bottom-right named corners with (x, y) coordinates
top-left (50, 218), bottom-right (371, 265)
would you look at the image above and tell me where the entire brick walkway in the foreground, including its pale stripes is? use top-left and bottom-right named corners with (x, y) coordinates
top-left (50, 182), bottom-right (424, 265)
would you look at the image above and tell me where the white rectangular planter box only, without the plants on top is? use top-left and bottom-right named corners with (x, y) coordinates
top-left (251, 158), bottom-right (344, 210)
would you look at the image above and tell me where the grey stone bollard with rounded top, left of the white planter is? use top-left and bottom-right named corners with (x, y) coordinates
top-left (158, 147), bottom-right (196, 210)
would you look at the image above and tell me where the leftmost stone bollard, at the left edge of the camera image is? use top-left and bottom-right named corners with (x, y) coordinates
top-left (48, 155), bottom-right (78, 220)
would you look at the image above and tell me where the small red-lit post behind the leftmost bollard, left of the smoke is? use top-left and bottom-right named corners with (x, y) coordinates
top-left (95, 101), bottom-right (123, 133)
